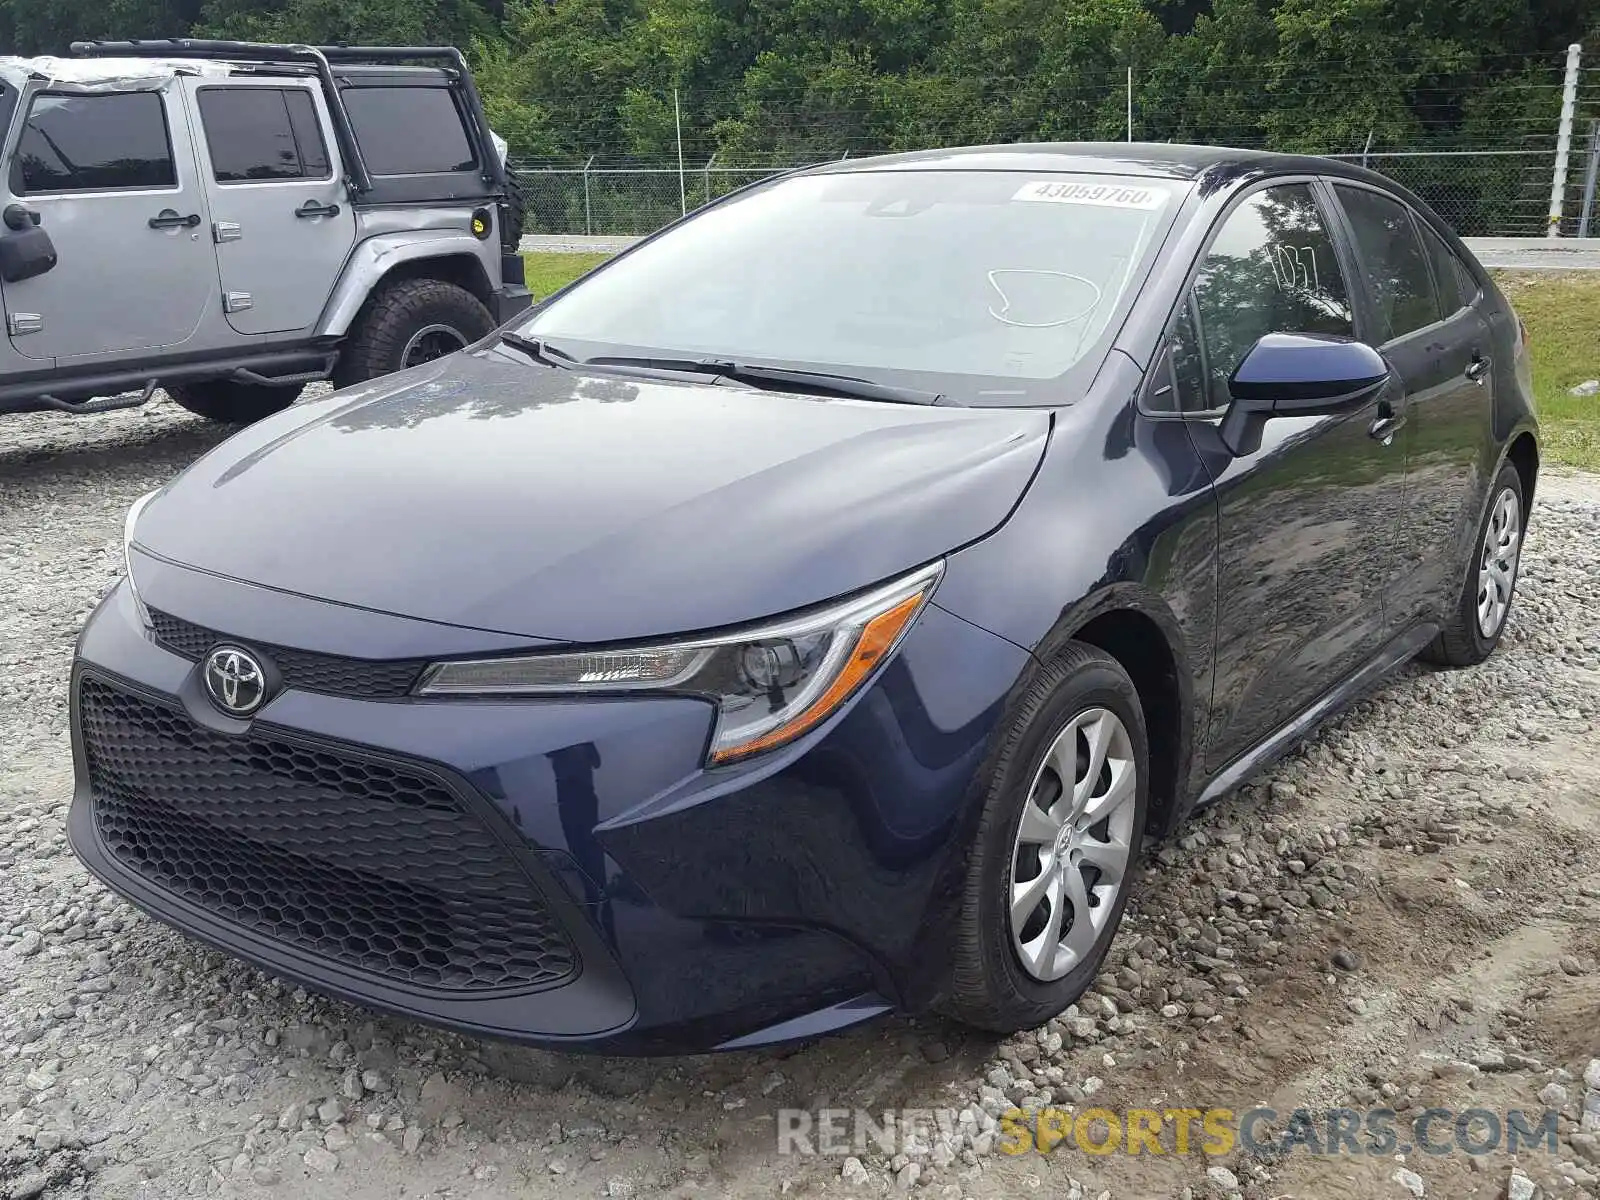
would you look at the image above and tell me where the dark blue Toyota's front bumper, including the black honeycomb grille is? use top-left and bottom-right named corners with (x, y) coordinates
top-left (69, 565), bottom-right (1024, 1053)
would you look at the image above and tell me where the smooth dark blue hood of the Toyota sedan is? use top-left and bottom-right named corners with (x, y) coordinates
top-left (136, 347), bottom-right (1050, 642)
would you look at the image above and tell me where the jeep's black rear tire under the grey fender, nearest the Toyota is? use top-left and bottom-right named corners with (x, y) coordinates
top-left (333, 278), bottom-right (494, 387)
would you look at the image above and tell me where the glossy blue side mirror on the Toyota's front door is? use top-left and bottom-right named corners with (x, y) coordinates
top-left (1219, 333), bottom-right (1389, 458)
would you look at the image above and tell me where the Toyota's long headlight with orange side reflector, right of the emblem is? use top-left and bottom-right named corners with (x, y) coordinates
top-left (418, 563), bottom-right (944, 763)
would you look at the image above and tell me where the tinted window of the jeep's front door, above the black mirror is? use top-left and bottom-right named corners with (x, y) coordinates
top-left (11, 91), bottom-right (178, 195)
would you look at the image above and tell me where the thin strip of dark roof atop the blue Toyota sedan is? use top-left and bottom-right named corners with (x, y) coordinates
top-left (810, 142), bottom-right (1394, 190)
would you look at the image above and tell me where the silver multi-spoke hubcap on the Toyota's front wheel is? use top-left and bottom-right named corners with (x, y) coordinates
top-left (1010, 709), bottom-right (1139, 982)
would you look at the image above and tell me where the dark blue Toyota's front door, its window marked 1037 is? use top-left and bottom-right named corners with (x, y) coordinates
top-left (1170, 179), bottom-right (1405, 771)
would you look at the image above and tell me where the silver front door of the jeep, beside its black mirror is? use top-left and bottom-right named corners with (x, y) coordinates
top-left (3, 85), bottom-right (216, 366)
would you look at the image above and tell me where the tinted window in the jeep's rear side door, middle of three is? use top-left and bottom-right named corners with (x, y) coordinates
top-left (200, 88), bottom-right (330, 184)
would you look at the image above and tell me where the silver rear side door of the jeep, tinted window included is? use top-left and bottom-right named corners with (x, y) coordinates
top-left (189, 77), bottom-right (355, 334)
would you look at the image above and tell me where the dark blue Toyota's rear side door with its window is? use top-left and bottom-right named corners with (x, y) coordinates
top-left (1334, 181), bottom-right (1494, 630)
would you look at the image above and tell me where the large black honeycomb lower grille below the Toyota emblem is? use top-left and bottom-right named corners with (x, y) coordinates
top-left (78, 677), bottom-right (578, 990)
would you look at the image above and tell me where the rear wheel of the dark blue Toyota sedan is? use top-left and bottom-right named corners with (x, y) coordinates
top-left (1421, 462), bottom-right (1526, 667)
